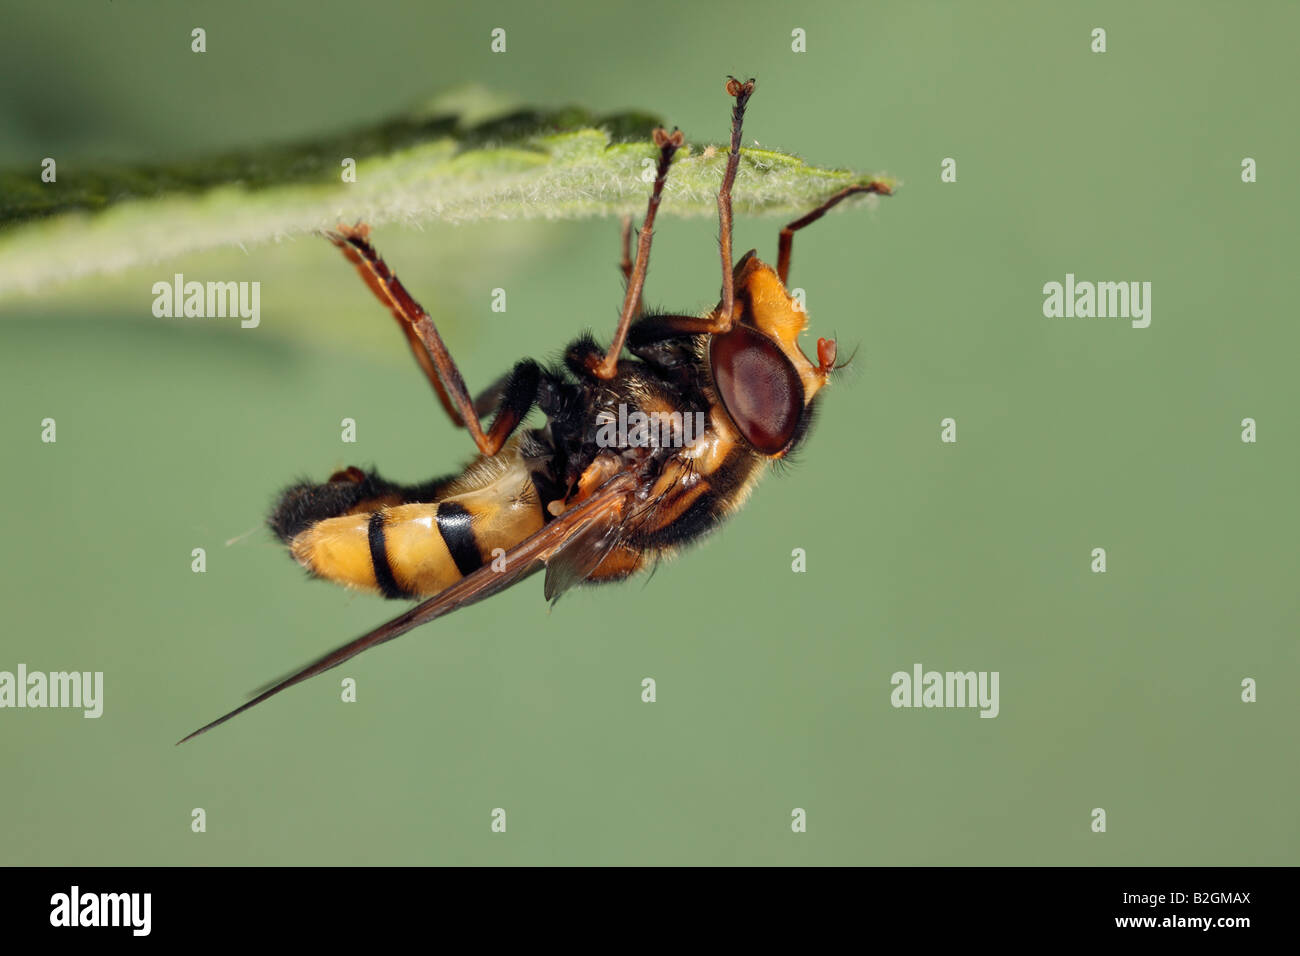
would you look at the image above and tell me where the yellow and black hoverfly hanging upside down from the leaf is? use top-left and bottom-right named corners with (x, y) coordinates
top-left (179, 77), bottom-right (889, 743)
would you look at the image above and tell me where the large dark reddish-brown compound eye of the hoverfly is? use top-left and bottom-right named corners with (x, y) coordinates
top-left (709, 325), bottom-right (803, 455)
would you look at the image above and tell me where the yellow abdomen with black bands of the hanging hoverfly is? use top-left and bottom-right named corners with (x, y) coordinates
top-left (272, 449), bottom-right (545, 598)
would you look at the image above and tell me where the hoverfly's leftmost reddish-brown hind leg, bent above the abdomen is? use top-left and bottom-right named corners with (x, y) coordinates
top-left (325, 224), bottom-right (537, 455)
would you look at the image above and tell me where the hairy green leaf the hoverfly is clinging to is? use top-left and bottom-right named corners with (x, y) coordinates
top-left (0, 90), bottom-right (891, 297)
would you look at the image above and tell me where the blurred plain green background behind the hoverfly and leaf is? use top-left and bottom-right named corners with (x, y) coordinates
top-left (0, 1), bottom-right (1300, 865)
